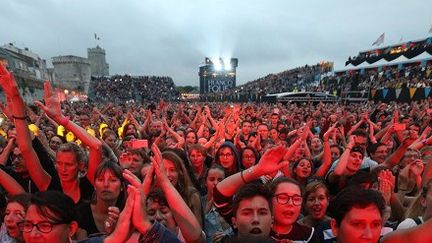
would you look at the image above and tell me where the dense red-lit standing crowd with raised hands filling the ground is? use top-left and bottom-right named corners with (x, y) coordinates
top-left (0, 59), bottom-right (432, 243)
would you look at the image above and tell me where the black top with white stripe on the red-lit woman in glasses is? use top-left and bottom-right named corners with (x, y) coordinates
top-left (270, 222), bottom-right (323, 243)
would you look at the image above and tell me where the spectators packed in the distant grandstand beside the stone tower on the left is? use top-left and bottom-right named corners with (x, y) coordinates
top-left (89, 75), bottom-right (180, 103)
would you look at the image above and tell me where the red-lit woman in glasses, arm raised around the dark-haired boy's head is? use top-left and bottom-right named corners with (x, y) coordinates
top-left (213, 146), bottom-right (321, 242)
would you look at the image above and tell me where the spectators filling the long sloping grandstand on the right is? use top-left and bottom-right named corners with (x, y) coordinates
top-left (203, 60), bottom-right (432, 102)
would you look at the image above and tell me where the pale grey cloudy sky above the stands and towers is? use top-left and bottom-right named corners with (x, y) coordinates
top-left (0, 0), bottom-right (432, 86)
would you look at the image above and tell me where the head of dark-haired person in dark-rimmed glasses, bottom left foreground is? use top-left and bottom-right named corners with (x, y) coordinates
top-left (18, 191), bottom-right (78, 243)
